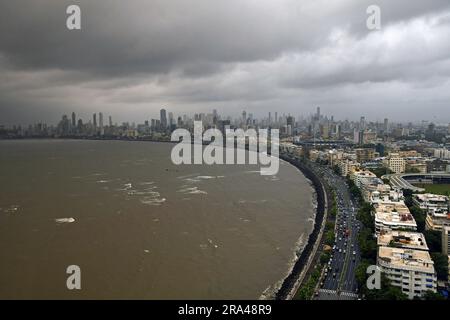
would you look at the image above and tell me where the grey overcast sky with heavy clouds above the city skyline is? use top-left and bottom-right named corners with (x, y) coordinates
top-left (0, 0), bottom-right (450, 124)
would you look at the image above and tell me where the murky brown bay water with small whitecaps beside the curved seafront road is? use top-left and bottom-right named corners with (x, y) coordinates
top-left (0, 140), bottom-right (315, 299)
